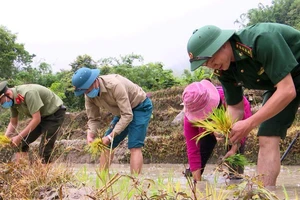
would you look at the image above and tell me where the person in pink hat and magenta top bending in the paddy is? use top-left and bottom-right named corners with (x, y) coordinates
top-left (182, 80), bottom-right (252, 181)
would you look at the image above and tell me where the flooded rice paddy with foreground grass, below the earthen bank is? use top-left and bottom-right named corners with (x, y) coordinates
top-left (0, 162), bottom-right (300, 200)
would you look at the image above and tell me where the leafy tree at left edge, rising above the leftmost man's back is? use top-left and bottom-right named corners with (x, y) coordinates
top-left (0, 26), bottom-right (35, 79)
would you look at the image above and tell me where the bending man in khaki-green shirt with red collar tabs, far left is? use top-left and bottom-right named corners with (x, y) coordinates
top-left (0, 81), bottom-right (66, 163)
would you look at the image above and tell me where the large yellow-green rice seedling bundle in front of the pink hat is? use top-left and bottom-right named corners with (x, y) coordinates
top-left (192, 106), bottom-right (233, 148)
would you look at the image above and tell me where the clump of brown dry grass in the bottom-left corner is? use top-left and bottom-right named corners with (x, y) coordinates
top-left (0, 160), bottom-right (73, 199)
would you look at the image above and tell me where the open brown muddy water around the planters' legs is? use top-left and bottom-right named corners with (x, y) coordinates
top-left (69, 164), bottom-right (300, 200)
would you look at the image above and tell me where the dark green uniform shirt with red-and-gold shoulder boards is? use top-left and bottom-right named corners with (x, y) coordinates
top-left (215, 23), bottom-right (300, 105)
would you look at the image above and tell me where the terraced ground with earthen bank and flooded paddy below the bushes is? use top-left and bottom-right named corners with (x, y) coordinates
top-left (0, 88), bottom-right (300, 200)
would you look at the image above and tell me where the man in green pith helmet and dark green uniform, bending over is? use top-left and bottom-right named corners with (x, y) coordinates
top-left (187, 23), bottom-right (300, 186)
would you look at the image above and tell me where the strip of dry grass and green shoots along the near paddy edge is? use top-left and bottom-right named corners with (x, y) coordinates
top-left (0, 157), bottom-right (288, 200)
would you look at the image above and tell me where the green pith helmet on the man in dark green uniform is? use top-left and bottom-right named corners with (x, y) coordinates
top-left (187, 25), bottom-right (235, 71)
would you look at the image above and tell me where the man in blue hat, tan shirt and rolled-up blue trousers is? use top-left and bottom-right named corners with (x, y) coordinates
top-left (72, 67), bottom-right (152, 174)
